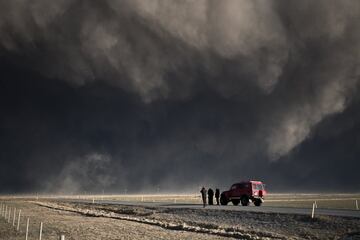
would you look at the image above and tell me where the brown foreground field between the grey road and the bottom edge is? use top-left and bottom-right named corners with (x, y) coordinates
top-left (0, 200), bottom-right (360, 240)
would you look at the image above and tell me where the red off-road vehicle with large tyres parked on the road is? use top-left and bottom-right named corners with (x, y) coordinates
top-left (220, 181), bottom-right (266, 206)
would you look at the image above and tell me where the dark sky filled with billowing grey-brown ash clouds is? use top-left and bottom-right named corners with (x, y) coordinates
top-left (0, 0), bottom-right (360, 193)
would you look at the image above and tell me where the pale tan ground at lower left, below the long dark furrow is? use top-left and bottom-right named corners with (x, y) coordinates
top-left (0, 201), bottom-right (228, 240)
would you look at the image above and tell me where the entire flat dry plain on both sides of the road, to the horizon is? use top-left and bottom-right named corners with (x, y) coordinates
top-left (0, 193), bottom-right (360, 240)
